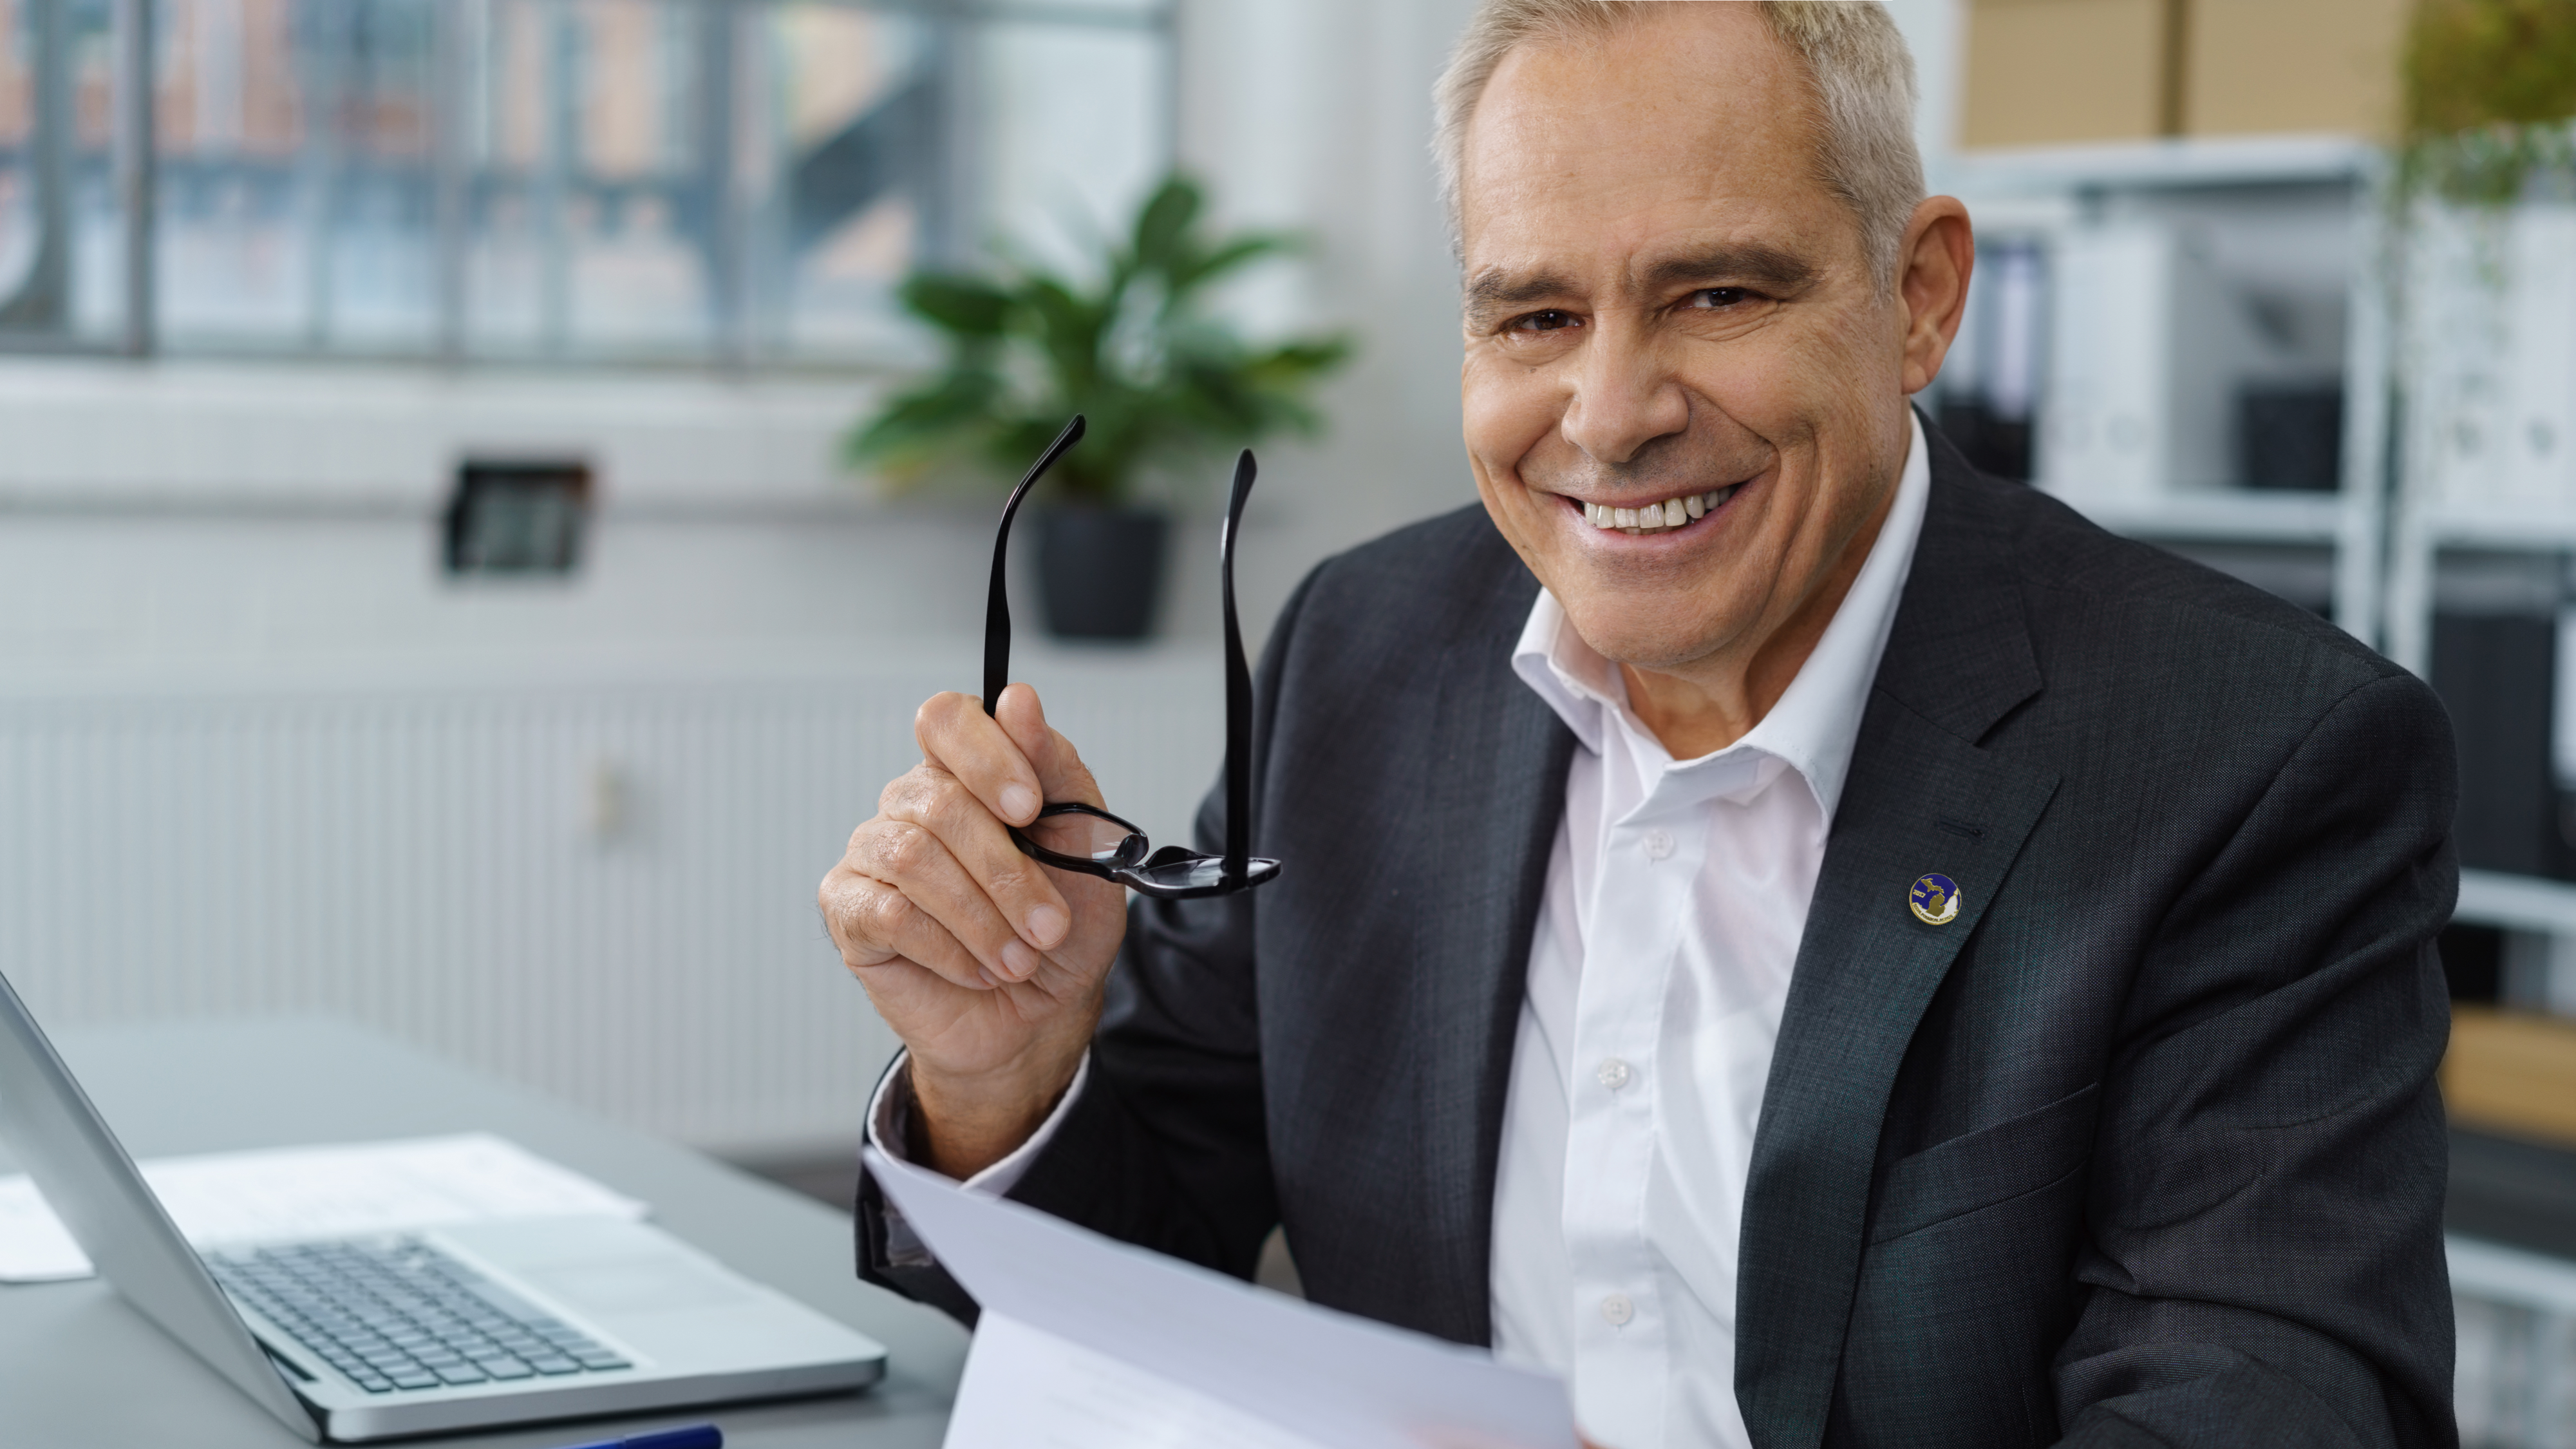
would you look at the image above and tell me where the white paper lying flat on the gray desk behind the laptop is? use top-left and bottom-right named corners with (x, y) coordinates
top-left (0, 1132), bottom-right (646, 1284)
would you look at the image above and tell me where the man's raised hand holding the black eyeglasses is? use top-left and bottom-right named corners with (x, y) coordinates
top-left (822, 683), bottom-right (1125, 1179)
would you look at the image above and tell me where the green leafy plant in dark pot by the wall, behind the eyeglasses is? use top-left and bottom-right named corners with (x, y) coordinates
top-left (847, 175), bottom-right (1350, 639)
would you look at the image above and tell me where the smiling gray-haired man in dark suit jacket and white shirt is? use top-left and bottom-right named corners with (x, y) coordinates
top-left (822, 0), bottom-right (2455, 1449)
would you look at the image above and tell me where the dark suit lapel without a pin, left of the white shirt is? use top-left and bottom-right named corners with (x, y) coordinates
top-left (1407, 539), bottom-right (1574, 1343)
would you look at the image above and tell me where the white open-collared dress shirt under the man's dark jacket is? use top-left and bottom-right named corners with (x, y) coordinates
top-left (868, 423), bottom-right (1932, 1449)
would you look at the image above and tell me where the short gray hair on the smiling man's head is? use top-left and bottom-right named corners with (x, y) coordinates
top-left (1433, 0), bottom-right (1924, 294)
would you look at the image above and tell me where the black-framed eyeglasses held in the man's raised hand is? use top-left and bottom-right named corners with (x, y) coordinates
top-left (984, 415), bottom-right (1280, 900)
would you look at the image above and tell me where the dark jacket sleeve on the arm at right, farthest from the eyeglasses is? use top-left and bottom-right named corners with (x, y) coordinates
top-left (2056, 676), bottom-right (2458, 1446)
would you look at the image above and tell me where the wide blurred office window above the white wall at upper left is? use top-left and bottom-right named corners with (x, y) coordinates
top-left (0, 0), bottom-right (1172, 364)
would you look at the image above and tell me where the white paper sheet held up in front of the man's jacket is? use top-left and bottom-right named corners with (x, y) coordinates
top-left (868, 1148), bottom-right (1577, 1449)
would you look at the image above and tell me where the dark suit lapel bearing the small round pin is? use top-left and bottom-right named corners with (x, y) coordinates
top-left (1736, 431), bottom-right (2058, 1449)
